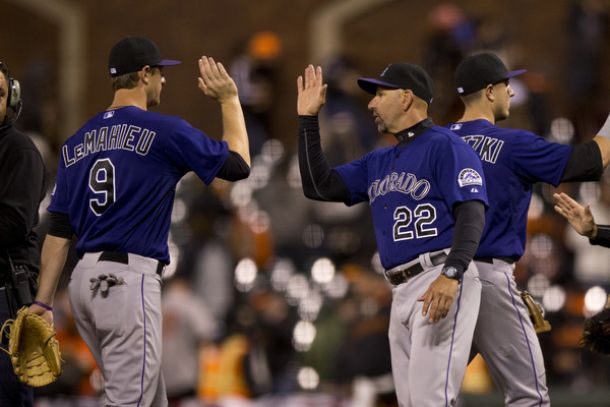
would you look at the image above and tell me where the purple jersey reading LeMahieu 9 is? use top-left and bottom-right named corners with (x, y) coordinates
top-left (48, 107), bottom-right (229, 263)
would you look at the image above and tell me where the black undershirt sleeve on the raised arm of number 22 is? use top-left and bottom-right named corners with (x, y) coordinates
top-left (299, 116), bottom-right (350, 204)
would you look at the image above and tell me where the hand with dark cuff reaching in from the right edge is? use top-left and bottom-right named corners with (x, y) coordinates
top-left (553, 192), bottom-right (610, 249)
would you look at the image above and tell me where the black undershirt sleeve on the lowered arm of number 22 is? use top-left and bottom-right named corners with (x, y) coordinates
top-left (445, 201), bottom-right (485, 274)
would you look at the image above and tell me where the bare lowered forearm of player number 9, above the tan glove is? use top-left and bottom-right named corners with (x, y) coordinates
top-left (36, 235), bottom-right (70, 305)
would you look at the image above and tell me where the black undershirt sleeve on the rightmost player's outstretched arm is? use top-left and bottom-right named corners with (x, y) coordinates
top-left (561, 140), bottom-right (604, 182)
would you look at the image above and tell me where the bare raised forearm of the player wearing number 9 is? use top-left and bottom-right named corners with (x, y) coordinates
top-left (220, 96), bottom-right (250, 165)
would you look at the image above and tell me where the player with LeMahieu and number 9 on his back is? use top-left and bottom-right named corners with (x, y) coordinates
top-left (30, 37), bottom-right (250, 406)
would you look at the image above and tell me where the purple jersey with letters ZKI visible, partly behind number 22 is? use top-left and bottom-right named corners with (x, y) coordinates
top-left (447, 120), bottom-right (572, 260)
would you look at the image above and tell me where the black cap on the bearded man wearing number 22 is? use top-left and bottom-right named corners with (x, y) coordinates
top-left (358, 63), bottom-right (434, 104)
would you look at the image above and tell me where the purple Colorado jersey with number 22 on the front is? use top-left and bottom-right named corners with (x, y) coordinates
top-left (335, 126), bottom-right (487, 269)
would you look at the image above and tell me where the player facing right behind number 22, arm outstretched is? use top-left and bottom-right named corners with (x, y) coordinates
top-left (448, 52), bottom-right (610, 407)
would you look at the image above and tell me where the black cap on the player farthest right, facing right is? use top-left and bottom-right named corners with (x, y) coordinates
top-left (455, 52), bottom-right (527, 96)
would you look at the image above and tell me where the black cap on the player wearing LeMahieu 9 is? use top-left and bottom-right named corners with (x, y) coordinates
top-left (108, 37), bottom-right (181, 77)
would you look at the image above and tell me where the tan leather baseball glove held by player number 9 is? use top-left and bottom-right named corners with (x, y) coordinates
top-left (2, 307), bottom-right (61, 387)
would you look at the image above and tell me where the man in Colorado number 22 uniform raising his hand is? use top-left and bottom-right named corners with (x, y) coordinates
top-left (297, 63), bottom-right (487, 407)
